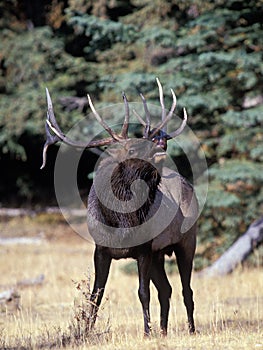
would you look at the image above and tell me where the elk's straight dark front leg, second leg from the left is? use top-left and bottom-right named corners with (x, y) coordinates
top-left (137, 253), bottom-right (152, 336)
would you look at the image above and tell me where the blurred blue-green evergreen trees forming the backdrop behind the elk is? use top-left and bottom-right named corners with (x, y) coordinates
top-left (0, 0), bottom-right (263, 264)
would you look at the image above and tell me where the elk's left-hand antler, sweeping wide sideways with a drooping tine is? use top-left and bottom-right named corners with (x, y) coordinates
top-left (40, 89), bottom-right (129, 169)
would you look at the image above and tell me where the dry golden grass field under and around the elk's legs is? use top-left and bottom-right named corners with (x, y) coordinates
top-left (0, 216), bottom-right (263, 350)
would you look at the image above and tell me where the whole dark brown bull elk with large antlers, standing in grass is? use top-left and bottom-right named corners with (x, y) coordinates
top-left (42, 79), bottom-right (198, 336)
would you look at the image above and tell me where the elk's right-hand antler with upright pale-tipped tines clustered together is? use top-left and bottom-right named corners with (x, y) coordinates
top-left (134, 78), bottom-right (187, 139)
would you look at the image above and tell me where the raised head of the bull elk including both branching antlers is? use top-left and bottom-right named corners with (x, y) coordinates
top-left (41, 78), bottom-right (187, 169)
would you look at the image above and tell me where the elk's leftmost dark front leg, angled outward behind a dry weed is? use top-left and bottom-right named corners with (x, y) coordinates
top-left (87, 246), bottom-right (111, 330)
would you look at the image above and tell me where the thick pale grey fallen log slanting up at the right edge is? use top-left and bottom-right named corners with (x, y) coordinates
top-left (198, 217), bottom-right (263, 277)
